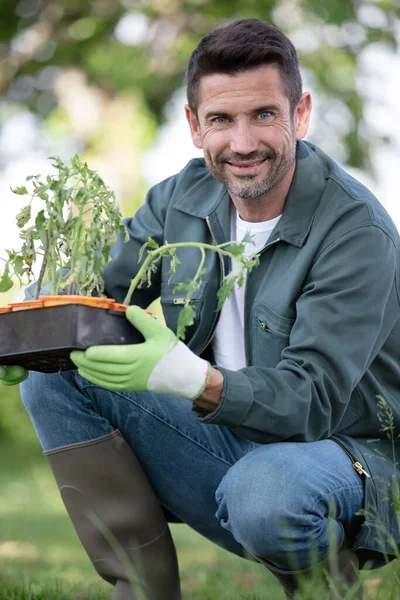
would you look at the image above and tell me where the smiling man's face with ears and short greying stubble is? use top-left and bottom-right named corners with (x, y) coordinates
top-left (186, 65), bottom-right (310, 199)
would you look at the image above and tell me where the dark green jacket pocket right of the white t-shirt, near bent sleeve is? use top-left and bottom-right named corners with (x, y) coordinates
top-left (251, 302), bottom-right (294, 367)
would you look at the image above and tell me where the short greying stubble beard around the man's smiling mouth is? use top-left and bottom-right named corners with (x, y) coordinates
top-left (204, 140), bottom-right (297, 200)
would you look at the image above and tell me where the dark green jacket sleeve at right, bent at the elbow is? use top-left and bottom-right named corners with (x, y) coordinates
top-left (198, 225), bottom-right (399, 443)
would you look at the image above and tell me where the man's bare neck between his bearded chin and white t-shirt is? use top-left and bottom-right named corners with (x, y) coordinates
top-left (230, 163), bottom-right (295, 223)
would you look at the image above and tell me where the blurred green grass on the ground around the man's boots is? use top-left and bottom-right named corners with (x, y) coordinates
top-left (0, 388), bottom-right (400, 600)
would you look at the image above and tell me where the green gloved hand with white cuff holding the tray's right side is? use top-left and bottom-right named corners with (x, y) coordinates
top-left (71, 306), bottom-right (211, 400)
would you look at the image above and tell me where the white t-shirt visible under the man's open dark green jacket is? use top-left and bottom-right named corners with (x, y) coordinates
top-left (212, 208), bottom-right (281, 371)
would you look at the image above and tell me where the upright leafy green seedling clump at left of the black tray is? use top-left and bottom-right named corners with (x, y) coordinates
top-left (0, 156), bottom-right (126, 299)
